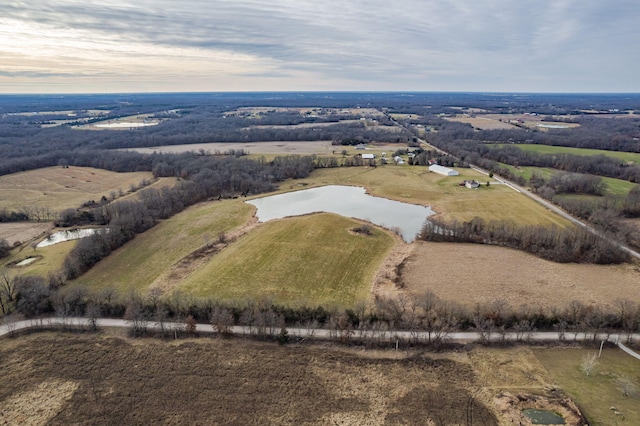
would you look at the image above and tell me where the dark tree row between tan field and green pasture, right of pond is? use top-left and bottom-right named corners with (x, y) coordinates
top-left (419, 217), bottom-right (630, 264)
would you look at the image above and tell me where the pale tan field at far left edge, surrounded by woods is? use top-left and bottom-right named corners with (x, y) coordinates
top-left (0, 167), bottom-right (166, 212)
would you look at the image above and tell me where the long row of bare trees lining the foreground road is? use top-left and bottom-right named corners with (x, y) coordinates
top-left (5, 274), bottom-right (640, 343)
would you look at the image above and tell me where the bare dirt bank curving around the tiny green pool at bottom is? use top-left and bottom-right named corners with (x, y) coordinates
top-left (494, 392), bottom-right (589, 426)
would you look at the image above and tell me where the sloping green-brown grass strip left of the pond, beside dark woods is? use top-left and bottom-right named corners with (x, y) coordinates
top-left (74, 200), bottom-right (253, 290)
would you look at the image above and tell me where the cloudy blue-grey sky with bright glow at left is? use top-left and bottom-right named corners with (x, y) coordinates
top-left (0, 0), bottom-right (640, 93)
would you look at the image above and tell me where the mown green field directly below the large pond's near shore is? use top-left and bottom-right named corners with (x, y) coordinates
top-left (177, 214), bottom-right (395, 307)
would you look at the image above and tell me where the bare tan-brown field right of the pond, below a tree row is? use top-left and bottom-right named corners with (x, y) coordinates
top-left (402, 242), bottom-right (640, 307)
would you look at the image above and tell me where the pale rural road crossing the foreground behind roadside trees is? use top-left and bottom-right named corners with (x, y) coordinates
top-left (0, 317), bottom-right (640, 352)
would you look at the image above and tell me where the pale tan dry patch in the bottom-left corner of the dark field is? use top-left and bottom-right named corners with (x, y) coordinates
top-left (0, 380), bottom-right (79, 425)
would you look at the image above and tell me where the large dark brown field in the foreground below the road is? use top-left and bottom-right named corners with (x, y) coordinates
top-left (0, 331), bottom-right (596, 425)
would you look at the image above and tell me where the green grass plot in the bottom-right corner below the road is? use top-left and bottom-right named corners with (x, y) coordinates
top-left (534, 348), bottom-right (640, 425)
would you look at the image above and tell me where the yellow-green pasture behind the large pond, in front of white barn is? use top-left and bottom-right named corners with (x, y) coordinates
top-left (281, 164), bottom-right (567, 226)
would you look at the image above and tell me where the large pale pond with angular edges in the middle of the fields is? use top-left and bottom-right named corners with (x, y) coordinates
top-left (247, 185), bottom-right (433, 242)
